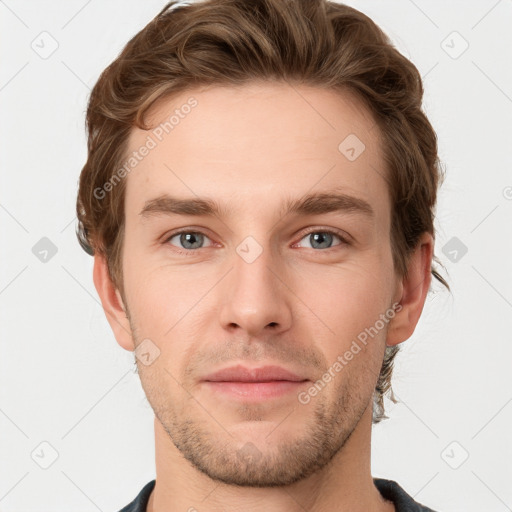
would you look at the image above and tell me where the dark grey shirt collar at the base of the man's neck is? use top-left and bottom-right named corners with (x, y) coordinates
top-left (119, 478), bottom-right (435, 512)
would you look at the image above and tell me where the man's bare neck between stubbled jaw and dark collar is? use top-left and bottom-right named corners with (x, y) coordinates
top-left (147, 406), bottom-right (395, 512)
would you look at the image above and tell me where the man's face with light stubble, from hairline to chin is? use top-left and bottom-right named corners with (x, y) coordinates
top-left (119, 84), bottom-right (398, 486)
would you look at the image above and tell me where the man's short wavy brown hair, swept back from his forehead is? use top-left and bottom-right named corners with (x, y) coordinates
top-left (77, 0), bottom-right (450, 423)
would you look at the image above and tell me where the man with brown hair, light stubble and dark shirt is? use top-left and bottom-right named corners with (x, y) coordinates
top-left (77, 0), bottom-right (447, 512)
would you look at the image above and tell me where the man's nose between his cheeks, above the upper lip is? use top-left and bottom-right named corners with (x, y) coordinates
top-left (220, 239), bottom-right (293, 336)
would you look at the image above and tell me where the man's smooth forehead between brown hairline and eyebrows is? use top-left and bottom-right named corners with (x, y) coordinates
top-left (126, 83), bottom-right (389, 220)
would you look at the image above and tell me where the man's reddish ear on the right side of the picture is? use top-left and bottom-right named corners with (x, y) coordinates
top-left (386, 232), bottom-right (434, 347)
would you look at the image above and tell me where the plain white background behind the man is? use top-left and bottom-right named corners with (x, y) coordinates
top-left (0, 0), bottom-right (512, 512)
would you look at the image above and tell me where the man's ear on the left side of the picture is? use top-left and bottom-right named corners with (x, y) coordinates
top-left (93, 254), bottom-right (135, 351)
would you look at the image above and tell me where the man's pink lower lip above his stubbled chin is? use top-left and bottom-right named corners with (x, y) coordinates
top-left (205, 380), bottom-right (308, 400)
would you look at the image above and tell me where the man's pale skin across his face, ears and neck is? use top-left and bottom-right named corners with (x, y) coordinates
top-left (94, 83), bottom-right (434, 512)
